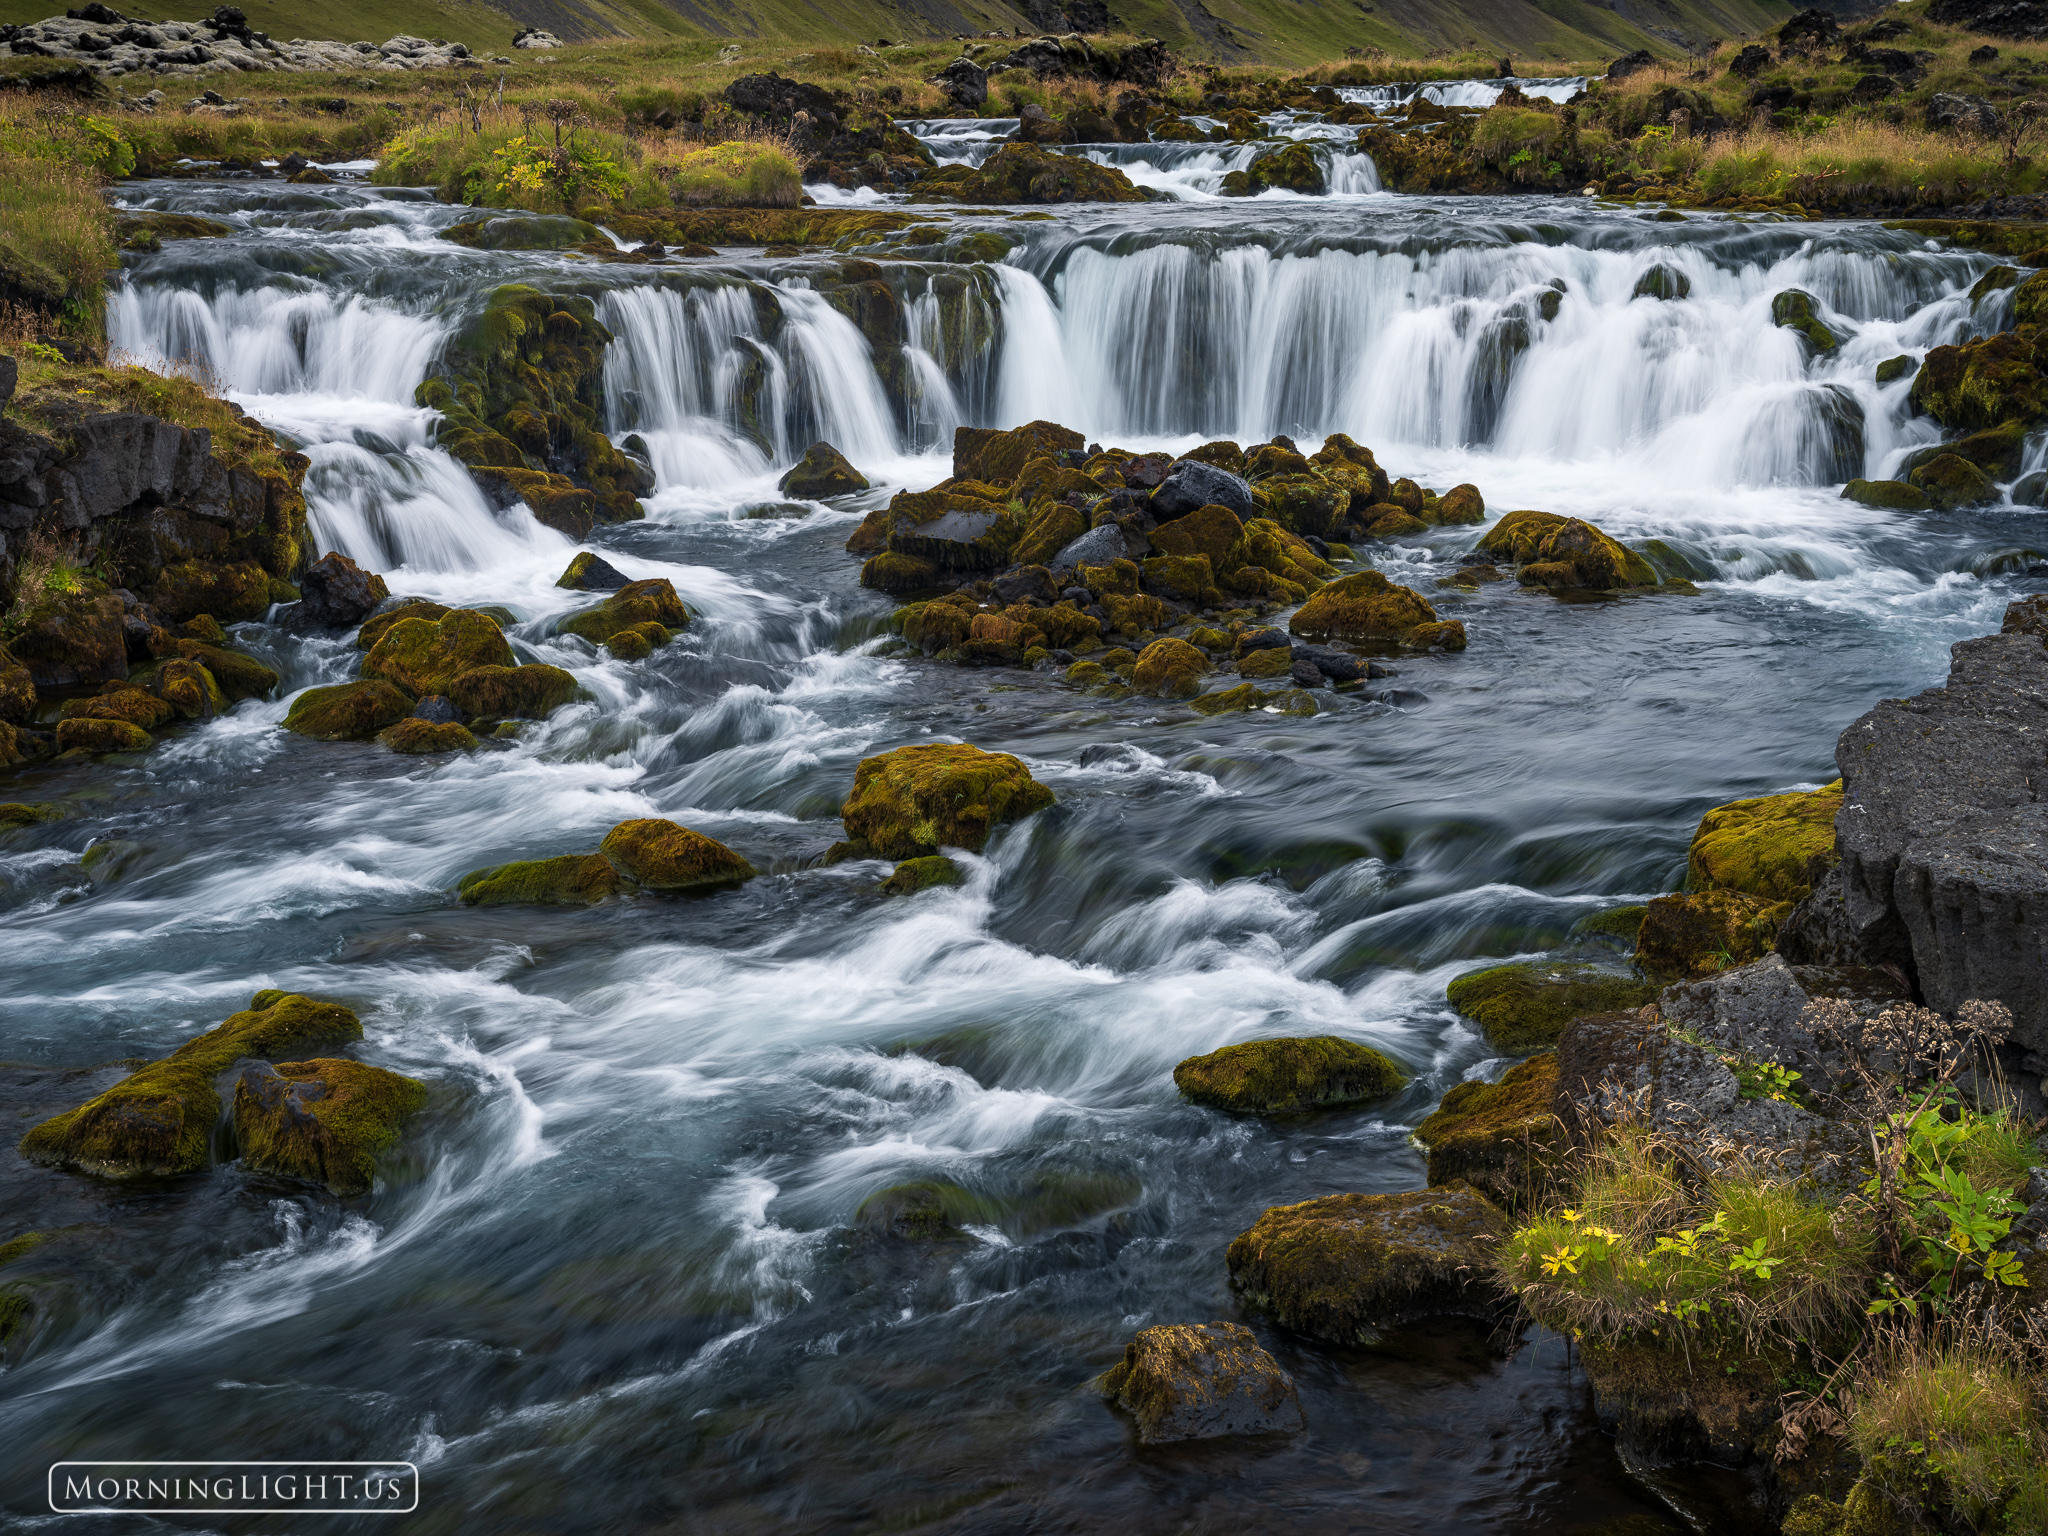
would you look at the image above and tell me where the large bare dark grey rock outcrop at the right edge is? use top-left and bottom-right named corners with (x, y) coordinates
top-left (1782, 598), bottom-right (2048, 1059)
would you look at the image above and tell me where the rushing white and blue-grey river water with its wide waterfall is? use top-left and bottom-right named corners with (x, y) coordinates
top-left (0, 99), bottom-right (2048, 1532)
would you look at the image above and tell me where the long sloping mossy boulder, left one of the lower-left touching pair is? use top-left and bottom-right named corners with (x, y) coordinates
top-left (20, 991), bottom-right (362, 1178)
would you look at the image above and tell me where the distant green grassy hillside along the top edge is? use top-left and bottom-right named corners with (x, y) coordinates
top-left (0, 0), bottom-right (1794, 66)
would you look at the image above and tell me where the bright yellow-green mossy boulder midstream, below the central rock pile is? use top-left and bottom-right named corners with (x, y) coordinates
top-left (840, 743), bottom-right (1053, 858)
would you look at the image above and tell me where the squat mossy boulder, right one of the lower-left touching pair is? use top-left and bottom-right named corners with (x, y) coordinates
top-left (233, 1057), bottom-right (426, 1196)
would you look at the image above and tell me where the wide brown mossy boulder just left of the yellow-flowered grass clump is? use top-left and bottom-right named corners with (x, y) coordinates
top-left (1225, 1184), bottom-right (1507, 1343)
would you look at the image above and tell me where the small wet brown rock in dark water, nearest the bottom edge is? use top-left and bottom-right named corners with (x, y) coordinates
top-left (1094, 1323), bottom-right (1307, 1446)
